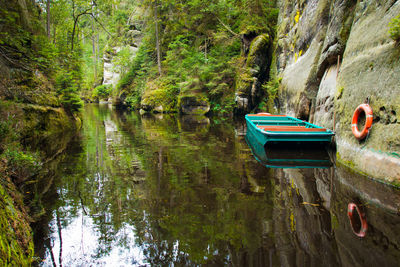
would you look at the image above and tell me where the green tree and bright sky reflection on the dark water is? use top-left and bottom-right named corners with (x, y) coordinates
top-left (37, 106), bottom-right (272, 266)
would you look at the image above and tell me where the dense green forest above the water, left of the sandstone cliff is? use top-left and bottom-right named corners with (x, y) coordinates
top-left (1, 0), bottom-right (278, 114)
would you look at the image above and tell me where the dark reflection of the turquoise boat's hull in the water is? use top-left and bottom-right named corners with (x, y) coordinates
top-left (246, 131), bottom-right (332, 168)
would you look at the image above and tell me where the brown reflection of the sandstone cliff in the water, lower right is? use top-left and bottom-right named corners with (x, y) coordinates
top-left (272, 164), bottom-right (400, 266)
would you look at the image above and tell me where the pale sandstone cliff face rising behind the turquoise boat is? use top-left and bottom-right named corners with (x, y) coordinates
top-left (272, 0), bottom-right (400, 182)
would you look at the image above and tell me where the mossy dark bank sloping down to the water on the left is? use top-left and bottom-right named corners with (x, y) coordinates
top-left (0, 100), bottom-right (81, 266)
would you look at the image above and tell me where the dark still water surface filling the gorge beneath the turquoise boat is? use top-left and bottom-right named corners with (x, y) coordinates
top-left (34, 105), bottom-right (400, 266)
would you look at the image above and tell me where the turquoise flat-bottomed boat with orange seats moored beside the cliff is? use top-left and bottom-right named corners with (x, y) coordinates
top-left (245, 113), bottom-right (334, 146)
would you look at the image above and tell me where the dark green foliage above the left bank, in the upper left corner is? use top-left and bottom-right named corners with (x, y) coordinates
top-left (0, 1), bottom-right (89, 111)
